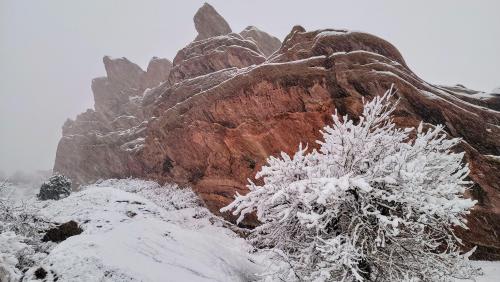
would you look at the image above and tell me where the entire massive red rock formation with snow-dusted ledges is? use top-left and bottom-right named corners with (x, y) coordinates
top-left (54, 5), bottom-right (500, 259)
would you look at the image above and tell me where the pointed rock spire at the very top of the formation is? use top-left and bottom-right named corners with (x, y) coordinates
top-left (193, 3), bottom-right (232, 40)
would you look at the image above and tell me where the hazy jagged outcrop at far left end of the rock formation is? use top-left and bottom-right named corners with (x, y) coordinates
top-left (54, 56), bottom-right (172, 187)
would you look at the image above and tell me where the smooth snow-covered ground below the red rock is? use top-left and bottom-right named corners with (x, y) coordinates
top-left (0, 180), bottom-right (500, 282)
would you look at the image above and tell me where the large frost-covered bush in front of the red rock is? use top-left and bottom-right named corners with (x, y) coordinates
top-left (221, 87), bottom-right (477, 281)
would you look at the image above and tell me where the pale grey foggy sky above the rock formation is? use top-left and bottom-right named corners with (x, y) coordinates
top-left (0, 0), bottom-right (500, 173)
